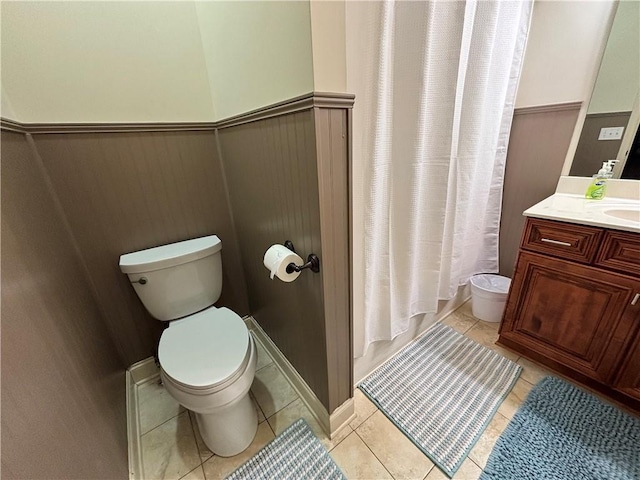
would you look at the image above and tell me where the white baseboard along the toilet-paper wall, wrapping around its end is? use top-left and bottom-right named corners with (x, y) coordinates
top-left (244, 316), bottom-right (355, 438)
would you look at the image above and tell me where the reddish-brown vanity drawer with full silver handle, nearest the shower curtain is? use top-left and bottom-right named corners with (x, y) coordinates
top-left (522, 218), bottom-right (603, 264)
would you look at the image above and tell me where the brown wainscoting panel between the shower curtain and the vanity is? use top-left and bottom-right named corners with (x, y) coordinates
top-left (500, 103), bottom-right (580, 277)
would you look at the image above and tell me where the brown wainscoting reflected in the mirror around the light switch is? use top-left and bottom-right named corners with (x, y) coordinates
top-left (569, 112), bottom-right (631, 177)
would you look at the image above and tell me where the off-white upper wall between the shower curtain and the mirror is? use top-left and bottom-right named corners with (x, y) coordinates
top-left (516, 0), bottom-right (615, 108)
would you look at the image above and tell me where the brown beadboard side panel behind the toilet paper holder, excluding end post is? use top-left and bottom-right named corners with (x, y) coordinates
top-left (218, 109), bottom-right (330, 411)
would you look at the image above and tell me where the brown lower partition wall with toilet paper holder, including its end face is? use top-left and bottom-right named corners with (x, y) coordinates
top-left (218, 108), bottom-right (352, 412)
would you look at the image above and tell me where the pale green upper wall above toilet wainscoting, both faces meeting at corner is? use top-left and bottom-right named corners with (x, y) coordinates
top-left (1, 0), bottom-right (316, 123)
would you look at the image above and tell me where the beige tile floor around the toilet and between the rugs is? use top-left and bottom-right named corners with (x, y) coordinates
top-left (136, 303), bottom-right (549, 480)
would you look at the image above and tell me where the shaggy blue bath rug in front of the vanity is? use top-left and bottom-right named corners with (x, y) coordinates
top-left (480, 377), bottom-right (640, 480)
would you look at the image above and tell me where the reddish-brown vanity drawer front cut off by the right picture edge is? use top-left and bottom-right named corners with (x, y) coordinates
top-left (596, 230), bottom-right (640, 277)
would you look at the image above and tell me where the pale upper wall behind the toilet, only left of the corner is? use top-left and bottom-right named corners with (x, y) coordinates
top-left (2, 1), bottom-right (214, 122)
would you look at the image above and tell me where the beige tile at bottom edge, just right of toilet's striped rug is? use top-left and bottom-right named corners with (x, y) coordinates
top-left (330, 432), bottom-right (393, 480)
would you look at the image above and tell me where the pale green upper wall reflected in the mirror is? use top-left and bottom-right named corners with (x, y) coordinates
top-left (588, 0), bottom-right (640, 113)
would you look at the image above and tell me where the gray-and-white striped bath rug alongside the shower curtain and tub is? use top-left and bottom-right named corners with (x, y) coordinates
top-left (358, 323), bottom-right (522, 477)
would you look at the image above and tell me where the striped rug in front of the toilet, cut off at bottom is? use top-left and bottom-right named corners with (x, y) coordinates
top-left (227, 418), bottom-right (346, 480)
